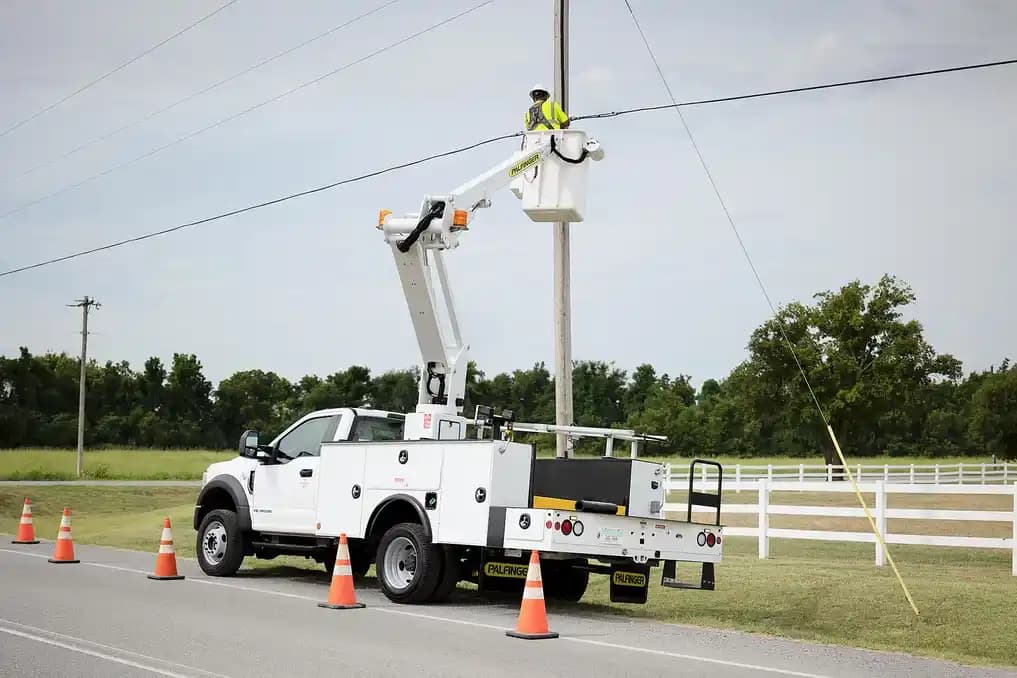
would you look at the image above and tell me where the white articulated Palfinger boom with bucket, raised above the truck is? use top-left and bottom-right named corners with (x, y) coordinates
top-left (377, 130), bottom-right (604, 440)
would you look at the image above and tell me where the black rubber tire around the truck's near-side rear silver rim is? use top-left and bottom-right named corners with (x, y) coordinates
top-left (374, 522), bottom-right (442, 605)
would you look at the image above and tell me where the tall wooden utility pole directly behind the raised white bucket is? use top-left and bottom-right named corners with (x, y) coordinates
top-left (553, 0), bottom-right (573, 457)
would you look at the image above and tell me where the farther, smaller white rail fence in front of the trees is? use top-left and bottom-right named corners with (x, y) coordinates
top-left (667, 463), bottom-right (1017, 490)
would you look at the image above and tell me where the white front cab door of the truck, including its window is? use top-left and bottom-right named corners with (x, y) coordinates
top-left (251, 415), bottom-right (340, 535)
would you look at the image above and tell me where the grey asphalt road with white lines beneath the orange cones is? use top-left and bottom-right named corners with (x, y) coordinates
top-left (0, 544), bottom-right (1017, 678)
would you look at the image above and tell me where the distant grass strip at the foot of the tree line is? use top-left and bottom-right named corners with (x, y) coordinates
top-left (0, 449), bottom-right (988, 481)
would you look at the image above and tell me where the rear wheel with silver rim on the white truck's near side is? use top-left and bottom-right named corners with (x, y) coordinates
top-left (374, 522), bottom-right (442, 604)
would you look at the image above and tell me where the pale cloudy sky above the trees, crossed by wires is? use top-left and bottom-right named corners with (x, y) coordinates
top-left (0, 0), bottom-right (1017, 384)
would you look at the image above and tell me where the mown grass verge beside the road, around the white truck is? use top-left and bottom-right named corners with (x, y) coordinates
top-left (0, 487), bottom-right (1017, 666)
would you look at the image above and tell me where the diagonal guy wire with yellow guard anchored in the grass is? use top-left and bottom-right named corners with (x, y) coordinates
top-left (624, 0), bottom-right (918, 615)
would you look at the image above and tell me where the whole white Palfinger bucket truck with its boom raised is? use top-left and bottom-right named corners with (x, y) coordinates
top-left (194, 129), bottom-right (723, 603)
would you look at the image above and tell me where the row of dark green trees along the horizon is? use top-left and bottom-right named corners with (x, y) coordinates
top-left (0, 275), bottom-right (1017, 461)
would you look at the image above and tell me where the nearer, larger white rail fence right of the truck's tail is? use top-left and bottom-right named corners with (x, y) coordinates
top-left (664, 478), bottom-right (1017, 576)
